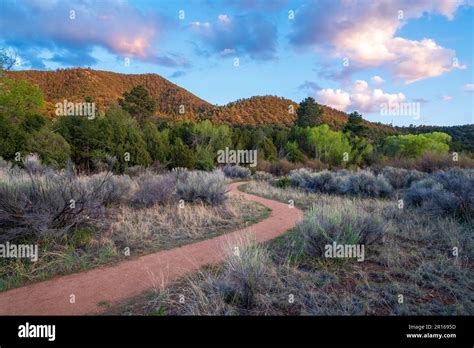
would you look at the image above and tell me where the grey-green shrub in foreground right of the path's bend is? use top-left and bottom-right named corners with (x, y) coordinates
top-left (297, 205), bottom-right (388, 257)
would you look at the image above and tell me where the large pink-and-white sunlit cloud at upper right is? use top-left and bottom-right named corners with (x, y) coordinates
top-left (289, 0), bottom-right (465, 83)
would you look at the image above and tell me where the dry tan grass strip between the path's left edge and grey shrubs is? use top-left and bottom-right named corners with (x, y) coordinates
top-left (0, 197), bottom-right (269, 290)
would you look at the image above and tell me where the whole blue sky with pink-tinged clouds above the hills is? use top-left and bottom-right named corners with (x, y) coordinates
top-left (0, 0), bottom-right (474, 126)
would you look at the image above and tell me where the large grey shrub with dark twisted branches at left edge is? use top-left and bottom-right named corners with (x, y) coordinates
top-left (0, 161), bottom-right (110, 240)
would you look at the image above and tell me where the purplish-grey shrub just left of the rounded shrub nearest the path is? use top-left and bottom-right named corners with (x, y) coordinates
top-left (132, 174), bottom-right (176, 207)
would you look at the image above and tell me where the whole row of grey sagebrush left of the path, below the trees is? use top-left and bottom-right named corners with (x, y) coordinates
top-left (0, 156), bottom-right (226, 240)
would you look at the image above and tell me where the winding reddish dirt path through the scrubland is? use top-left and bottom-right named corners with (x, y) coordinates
top-left (0, 182), bottom-right (303, 315)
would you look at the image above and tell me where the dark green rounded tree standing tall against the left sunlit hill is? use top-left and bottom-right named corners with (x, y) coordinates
top-left (118, 85), bottom-right (156, 124)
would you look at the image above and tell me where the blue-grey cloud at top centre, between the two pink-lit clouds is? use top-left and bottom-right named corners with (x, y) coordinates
top-left (190, 14), bottom-right (277, 60)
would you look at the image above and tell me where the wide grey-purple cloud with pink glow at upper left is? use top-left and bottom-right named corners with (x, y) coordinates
top-left (0, 0), bottom-right (189, 66)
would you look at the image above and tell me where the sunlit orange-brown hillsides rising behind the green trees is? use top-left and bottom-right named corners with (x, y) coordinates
top-left (0, 68), bottom-right (424, 140)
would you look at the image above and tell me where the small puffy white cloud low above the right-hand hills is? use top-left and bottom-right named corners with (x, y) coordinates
top-left (315, 80), bottom-right (406, 113)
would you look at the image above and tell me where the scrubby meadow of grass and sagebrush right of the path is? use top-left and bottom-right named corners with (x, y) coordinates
top-left (110, 167), bottom-right (474, 315)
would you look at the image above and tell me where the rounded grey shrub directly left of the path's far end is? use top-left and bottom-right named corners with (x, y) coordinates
top-left (176, 170), bottom-right (226, 204)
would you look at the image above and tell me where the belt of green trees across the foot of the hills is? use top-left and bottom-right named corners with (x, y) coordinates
top-left (0, 71), bottom-right (474, 175)
